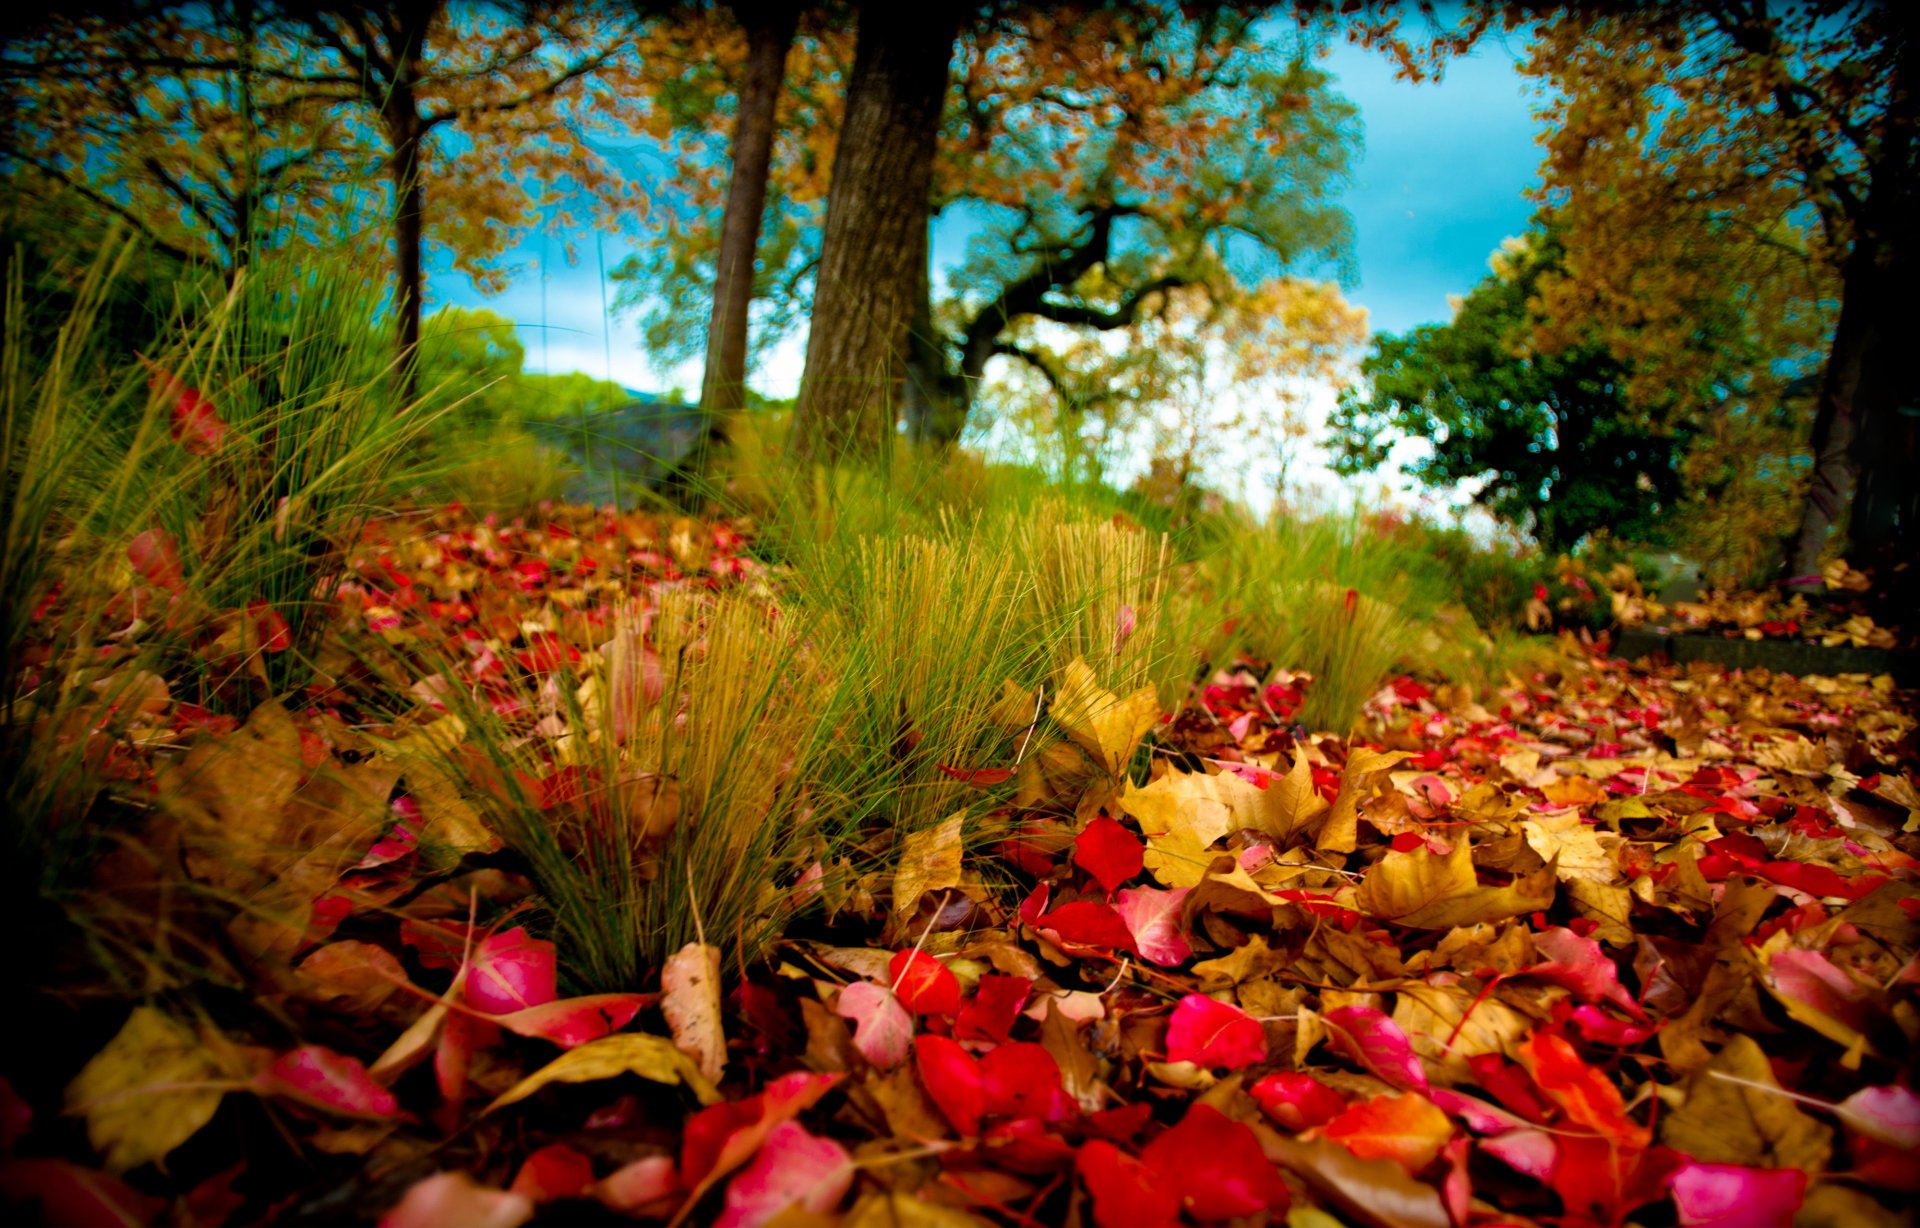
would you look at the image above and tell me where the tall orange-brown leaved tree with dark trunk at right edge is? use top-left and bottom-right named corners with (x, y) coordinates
top-left (1361, 0), bottom-right (1920, 587)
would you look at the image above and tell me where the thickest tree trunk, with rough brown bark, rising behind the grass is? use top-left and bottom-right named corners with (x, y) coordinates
top-left (793, 0), bottom-right (960, 461)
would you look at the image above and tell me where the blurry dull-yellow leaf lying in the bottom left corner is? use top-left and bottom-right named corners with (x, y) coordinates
top-left (67, 1005), bottom-right (223, 1172)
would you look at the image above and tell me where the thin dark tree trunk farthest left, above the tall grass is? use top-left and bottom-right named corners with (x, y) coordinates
top-left (380, 0), bottom-right (440, 405)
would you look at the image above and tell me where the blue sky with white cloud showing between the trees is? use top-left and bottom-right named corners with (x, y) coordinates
top-left (428, 29), bottom-right (1540, 506)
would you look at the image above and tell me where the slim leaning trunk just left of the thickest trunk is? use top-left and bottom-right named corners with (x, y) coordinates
top-left (701, 0), bottom-right (799, 451)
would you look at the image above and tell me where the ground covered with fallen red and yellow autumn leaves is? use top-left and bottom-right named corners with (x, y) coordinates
top-left (0, 510), bottom-right (1920, 1228)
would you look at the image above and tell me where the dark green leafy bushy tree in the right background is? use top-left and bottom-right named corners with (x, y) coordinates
top-left (1331, 236), bottom-right (1688, 551)
